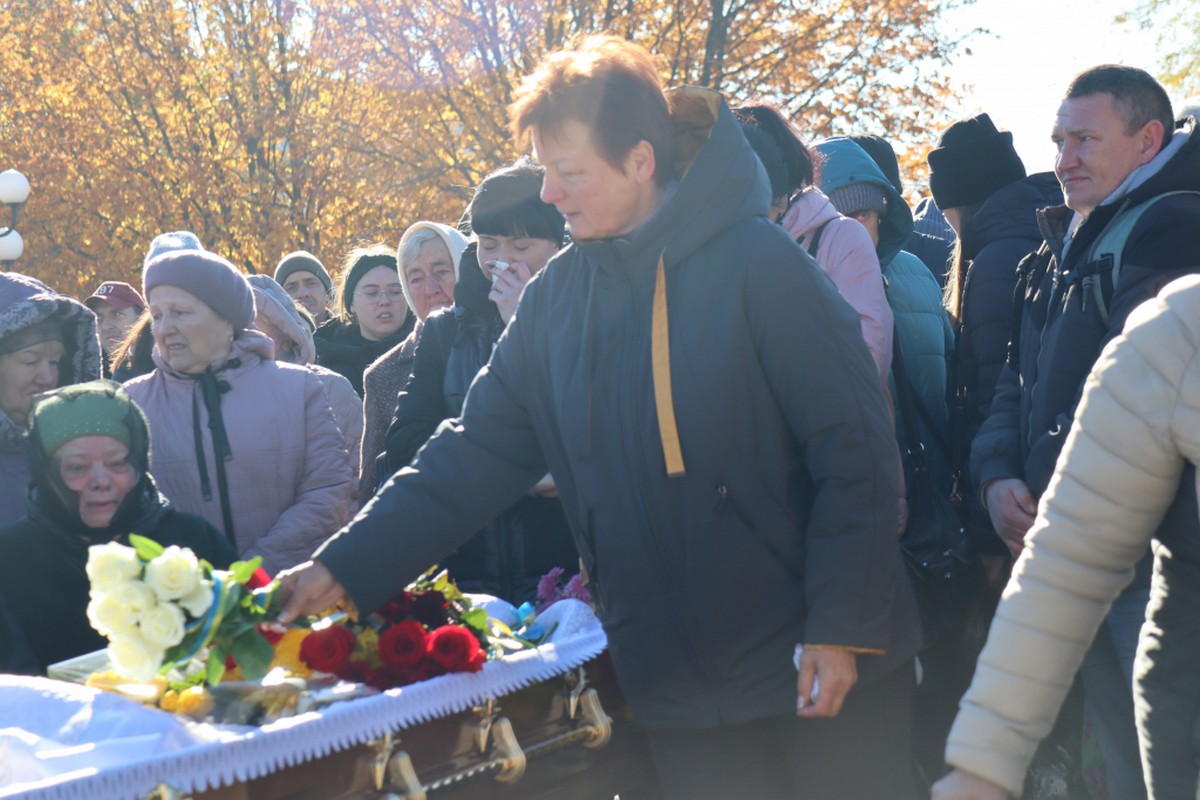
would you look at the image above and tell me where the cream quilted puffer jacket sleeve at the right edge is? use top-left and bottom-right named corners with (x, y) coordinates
top-left (946, 276), bottom-right (1200, 795)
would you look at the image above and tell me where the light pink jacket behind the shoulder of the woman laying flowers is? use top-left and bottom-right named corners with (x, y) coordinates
top-left (782, 186), bottom-right (893, 386)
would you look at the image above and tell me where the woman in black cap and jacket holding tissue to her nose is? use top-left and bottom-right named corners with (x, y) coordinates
top-left (386, 158), bottom-right (578, 604)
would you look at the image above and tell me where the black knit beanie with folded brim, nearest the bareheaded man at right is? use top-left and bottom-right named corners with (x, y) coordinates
top-left (929, 114), bottom-right (1025, 210)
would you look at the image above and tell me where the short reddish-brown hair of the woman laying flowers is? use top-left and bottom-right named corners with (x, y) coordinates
top-left (509, 36), bottom-right (674, 186)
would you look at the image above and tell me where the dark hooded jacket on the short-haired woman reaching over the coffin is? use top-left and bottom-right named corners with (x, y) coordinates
top-left (316, 89), bottom-right (920, 728)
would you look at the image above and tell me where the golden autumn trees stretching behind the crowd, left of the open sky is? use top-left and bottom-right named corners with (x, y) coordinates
top-left (0, 0), bottom-right (958, 294)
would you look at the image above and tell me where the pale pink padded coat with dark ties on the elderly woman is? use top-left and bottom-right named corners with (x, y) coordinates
top-left (125, 330), bottom-right (355, 575)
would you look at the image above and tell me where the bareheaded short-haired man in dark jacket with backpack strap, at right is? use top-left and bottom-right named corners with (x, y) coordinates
top-left (971, 66), bottom-right (1200, 798)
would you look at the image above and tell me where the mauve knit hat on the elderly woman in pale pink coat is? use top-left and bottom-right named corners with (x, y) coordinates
top-left (142, 249), bottom-right (254, 335)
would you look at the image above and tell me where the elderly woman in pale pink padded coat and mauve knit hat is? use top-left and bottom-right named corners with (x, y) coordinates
top-left (126, 251), bottom-right (355, 573)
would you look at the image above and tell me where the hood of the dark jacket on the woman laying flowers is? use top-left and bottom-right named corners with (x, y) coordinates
top-left (576, 86), bottom-right (770, 267)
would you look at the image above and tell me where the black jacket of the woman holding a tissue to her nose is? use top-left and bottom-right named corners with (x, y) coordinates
top-left (385, 243), bottom-right (580, 604)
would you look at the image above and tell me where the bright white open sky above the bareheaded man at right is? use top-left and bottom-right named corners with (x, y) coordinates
top-left (931, 0), bottom-right (1178, 173)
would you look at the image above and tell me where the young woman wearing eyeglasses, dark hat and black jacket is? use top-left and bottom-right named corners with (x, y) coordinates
top-left (313, 245), bottom-right (416, 397)
